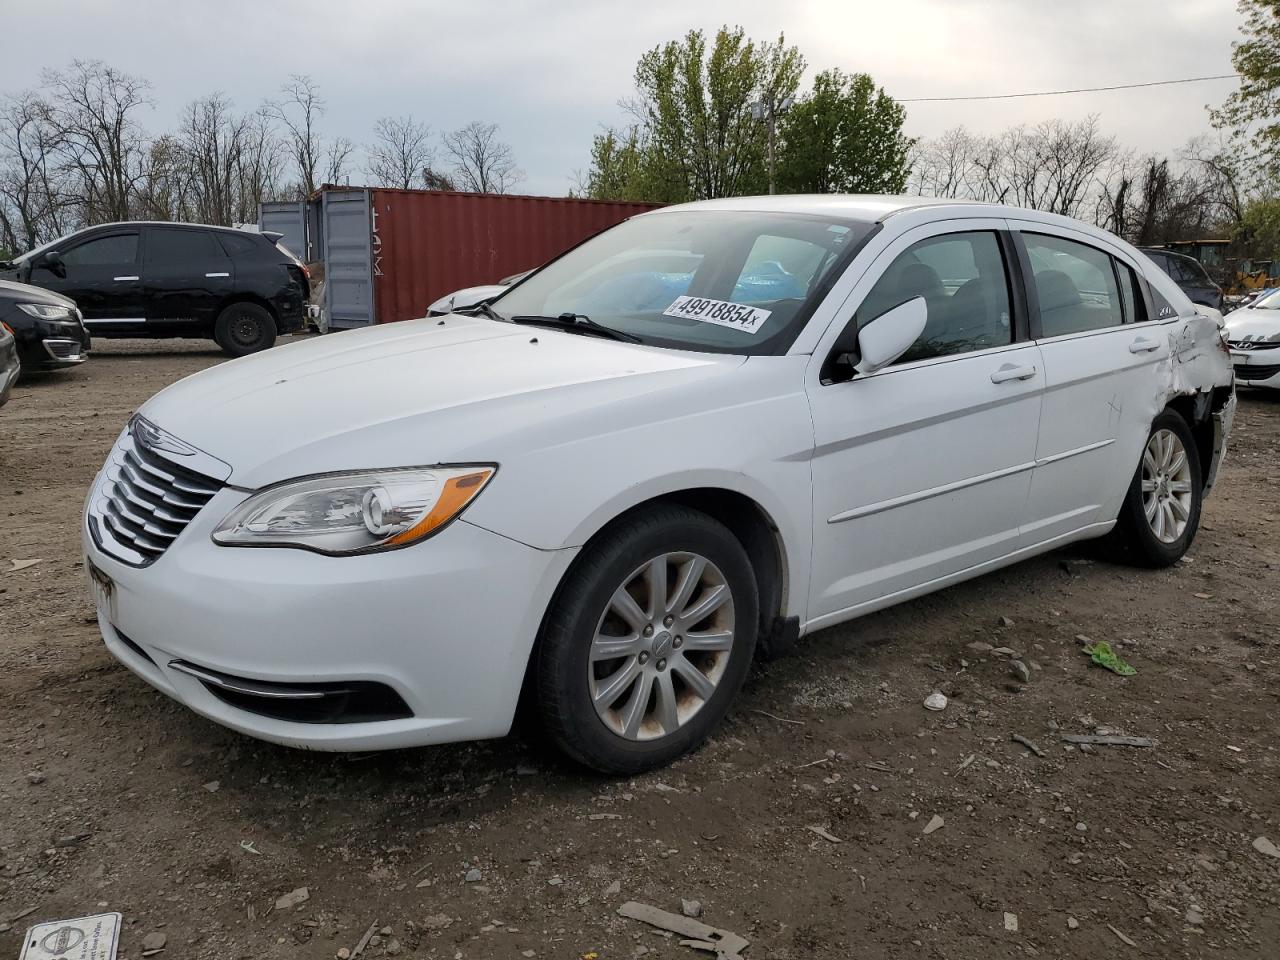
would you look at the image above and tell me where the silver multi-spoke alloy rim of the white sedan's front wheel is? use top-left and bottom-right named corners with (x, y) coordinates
top-left (588, 552), bottom-right (733, 741)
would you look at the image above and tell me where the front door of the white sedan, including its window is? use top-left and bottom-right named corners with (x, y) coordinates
top-left (809, 220), bottom-right (1044, 627)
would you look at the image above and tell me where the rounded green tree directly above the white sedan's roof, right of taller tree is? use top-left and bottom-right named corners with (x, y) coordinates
top-left (778, 69), bottom-right (914, 193)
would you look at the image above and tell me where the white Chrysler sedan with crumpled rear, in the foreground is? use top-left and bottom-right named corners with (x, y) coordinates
top-left (84, 196), bottom-right (1235, 773)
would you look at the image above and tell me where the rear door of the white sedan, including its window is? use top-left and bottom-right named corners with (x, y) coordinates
top-left (1011, 221), bottom-right (1170, 541)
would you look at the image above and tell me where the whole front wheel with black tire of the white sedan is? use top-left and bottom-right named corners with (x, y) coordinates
top-left (535, 506), bottom-right (759, 776)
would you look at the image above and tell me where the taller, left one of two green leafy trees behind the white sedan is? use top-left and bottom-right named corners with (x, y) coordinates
top-left (586, 27), bottom-right (804, 204)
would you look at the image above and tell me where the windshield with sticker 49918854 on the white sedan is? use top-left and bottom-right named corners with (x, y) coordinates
top-left (493, 211), bottom-right (873, 353)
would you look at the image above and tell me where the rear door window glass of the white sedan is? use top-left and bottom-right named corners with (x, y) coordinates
top-left (1023, 233), bottom-right (1124, 337)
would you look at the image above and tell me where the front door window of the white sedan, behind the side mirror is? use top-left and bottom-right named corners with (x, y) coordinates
top-left (858, 233), bottom-right (1012, 364)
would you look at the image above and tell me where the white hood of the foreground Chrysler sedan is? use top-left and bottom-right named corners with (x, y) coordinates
top-left (140, 315), bottom-right (745, 488)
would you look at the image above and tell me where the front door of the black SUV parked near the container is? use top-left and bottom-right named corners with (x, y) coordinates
top-left (31, 227), bottom-right (145, 333)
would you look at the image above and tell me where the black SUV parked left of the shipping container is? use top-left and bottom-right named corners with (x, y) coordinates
top-left (0, 223), bottom-right (311, 357)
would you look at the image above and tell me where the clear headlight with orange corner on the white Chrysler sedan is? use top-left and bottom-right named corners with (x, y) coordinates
top-left (214, 465), bottom-right (497, 557)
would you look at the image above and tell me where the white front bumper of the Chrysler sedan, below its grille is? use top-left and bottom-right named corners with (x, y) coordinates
top-left (82, 488), bottom-right (573, 750)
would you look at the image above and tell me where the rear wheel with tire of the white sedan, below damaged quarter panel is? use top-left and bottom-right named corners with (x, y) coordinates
top-left (1111, 410), bottom-right (1203, 567)
